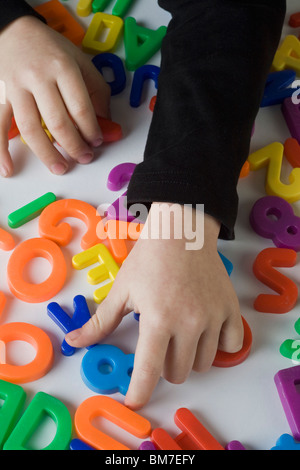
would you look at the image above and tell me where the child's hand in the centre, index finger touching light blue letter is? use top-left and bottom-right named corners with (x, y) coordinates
top-left (66, 205), bottom-right (244, 409)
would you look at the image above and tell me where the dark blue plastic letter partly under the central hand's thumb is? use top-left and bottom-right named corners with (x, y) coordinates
top-left (47, 295), bottom-right (92, 356)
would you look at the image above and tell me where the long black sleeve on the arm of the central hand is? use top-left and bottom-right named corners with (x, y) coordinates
top-left (127, 0), bottom-right (286, 239)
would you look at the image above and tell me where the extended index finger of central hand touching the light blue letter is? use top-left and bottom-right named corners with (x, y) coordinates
top-left (125, 315), bottom-right (170, 410)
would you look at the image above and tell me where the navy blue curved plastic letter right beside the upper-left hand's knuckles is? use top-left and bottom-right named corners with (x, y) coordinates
top-left (92, 52), bottom-right (126, 96)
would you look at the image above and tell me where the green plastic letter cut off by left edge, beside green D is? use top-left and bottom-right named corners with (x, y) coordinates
top-left (0, 380), bottom-right (26, 449)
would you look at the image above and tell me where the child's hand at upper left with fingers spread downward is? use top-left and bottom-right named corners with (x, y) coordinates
top-left (0, 16), bottom-right (110, 176)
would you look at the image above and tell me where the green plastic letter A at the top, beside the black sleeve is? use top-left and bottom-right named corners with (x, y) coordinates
top-left (124, 17), bottom-right (167, 71)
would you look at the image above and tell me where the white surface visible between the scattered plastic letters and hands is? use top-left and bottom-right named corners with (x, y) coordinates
top-left (0, 0), bottom-right (300, 450)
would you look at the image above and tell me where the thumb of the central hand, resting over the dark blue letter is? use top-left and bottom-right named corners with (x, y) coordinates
top-left (65, 281), bottom-right (131, 348)
